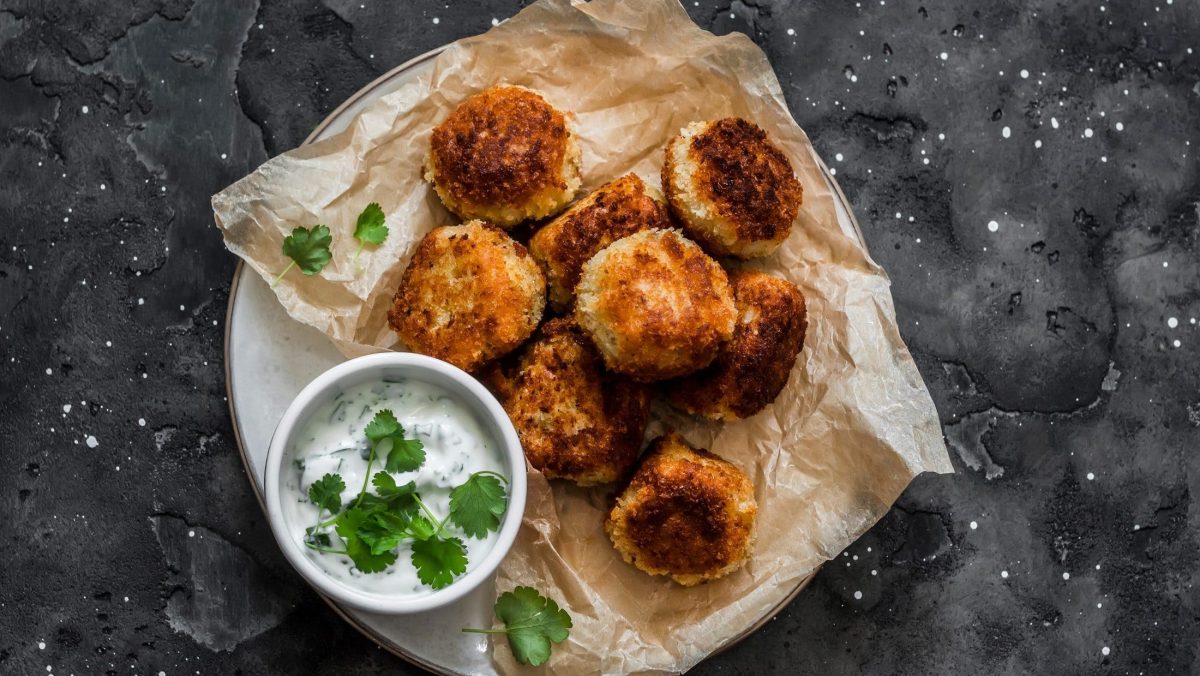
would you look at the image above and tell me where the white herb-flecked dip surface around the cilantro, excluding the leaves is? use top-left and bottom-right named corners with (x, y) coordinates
top-left (281, 378), bottom-right (508, 598)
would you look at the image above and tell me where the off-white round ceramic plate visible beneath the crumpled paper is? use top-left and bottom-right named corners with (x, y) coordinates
top-left (224, 48), bottom-right (865, 675)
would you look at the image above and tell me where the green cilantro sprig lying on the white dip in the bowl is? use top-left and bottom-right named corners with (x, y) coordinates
top-left (305, 408), bottom-right (508, 590)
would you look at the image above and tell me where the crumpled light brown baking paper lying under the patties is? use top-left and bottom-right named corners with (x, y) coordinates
top-left (212, 0), bottom-right (952, 675)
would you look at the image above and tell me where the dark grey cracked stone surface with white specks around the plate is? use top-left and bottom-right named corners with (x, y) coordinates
top-left (0, 0), bottom-right (1200, 675)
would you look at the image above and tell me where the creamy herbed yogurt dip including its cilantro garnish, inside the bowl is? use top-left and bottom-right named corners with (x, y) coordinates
top-left (281, 378), bottom-right (508, 597)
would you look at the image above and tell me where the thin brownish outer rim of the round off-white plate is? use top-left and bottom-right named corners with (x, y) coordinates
top-left (222, 43), bottom-right (870, 676)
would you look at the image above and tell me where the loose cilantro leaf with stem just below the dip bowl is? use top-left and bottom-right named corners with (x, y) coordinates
top-left (463, 587), bottom-right (571, 666)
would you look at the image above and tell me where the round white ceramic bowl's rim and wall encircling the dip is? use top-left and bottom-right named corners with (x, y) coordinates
top-left (264, 352), bottom-right (526, 615)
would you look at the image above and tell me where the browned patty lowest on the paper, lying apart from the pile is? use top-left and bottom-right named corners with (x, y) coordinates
top-left (605, 432), bottom-right (758, 587)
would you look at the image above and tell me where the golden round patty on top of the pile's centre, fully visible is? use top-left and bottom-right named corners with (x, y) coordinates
top-left (575, 229), bottom-right (737, 382)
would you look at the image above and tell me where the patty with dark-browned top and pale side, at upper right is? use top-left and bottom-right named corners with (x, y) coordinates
top-left (662, 118), bottom-right (804, 258)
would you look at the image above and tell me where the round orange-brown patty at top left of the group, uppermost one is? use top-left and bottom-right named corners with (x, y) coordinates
top-left (425, 85), bottom-right (582, 228)
